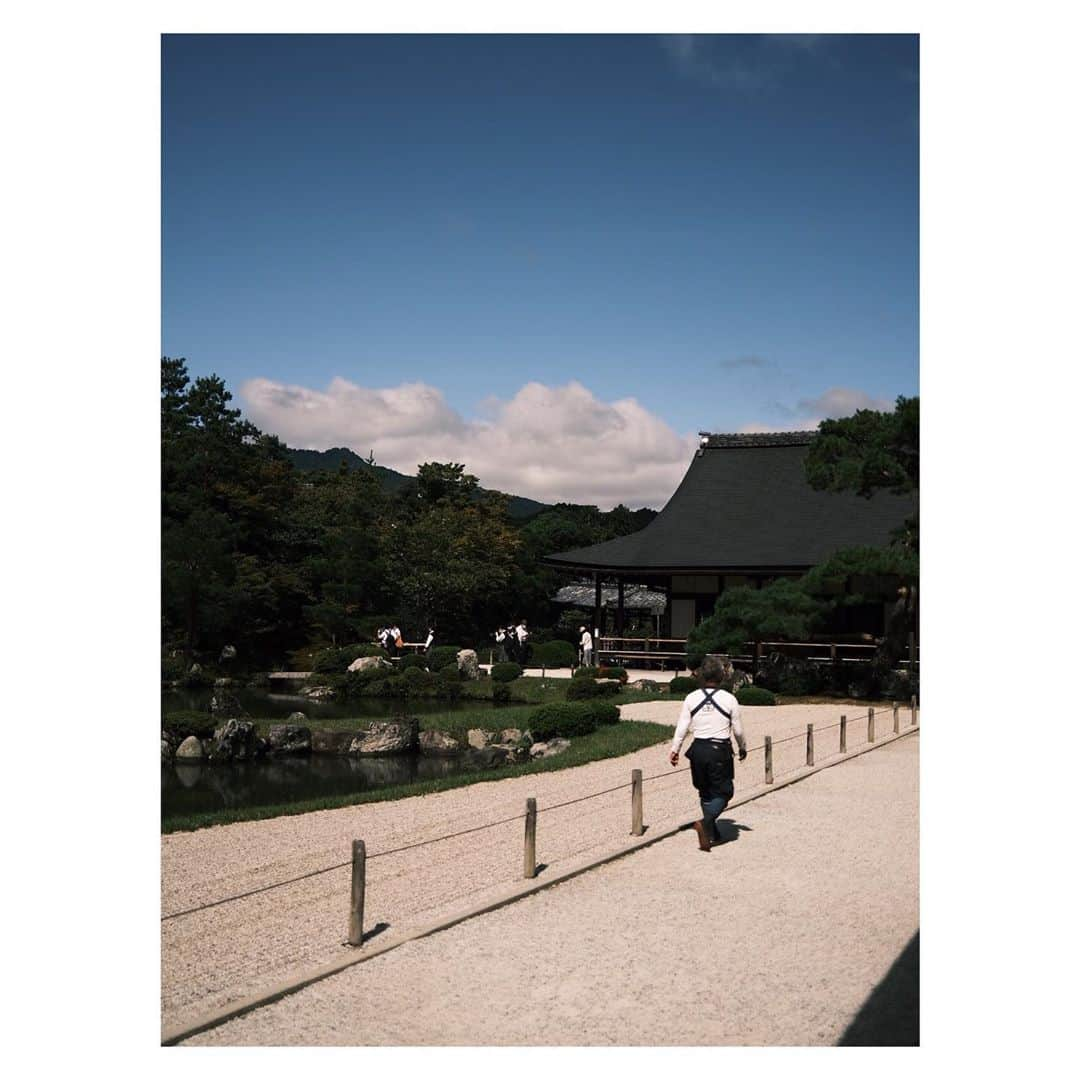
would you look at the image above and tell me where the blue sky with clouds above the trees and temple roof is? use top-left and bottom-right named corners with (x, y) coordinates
top-left (162, 36), bottom-right (918, 503)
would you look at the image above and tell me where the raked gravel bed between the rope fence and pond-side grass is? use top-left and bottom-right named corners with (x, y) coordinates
top-left (161, 702), bottom-right (907, 1041)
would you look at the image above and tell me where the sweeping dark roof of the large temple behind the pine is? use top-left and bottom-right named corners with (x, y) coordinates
top-left (545, 432), bottom-right (912, 571)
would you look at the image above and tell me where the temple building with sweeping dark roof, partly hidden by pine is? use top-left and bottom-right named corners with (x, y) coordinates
top-left (544, 431), bottom-right (913, 639)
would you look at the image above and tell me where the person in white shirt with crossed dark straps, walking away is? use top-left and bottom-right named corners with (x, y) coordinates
top-left (667, 657), bottom-right (746, 851)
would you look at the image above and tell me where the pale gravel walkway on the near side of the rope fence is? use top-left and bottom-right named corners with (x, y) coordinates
top-left (190, 735), bottom-right (918, 1045)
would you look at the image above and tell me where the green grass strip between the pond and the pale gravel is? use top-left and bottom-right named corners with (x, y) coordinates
top-left (161, 725), bottom-right (674, 833)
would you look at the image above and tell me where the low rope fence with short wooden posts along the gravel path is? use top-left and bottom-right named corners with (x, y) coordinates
top-left (161, 698), bottom-right (918, 928)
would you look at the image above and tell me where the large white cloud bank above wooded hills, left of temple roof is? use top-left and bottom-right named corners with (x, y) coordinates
top-left (240, 378), bottom-right (698, 509)
